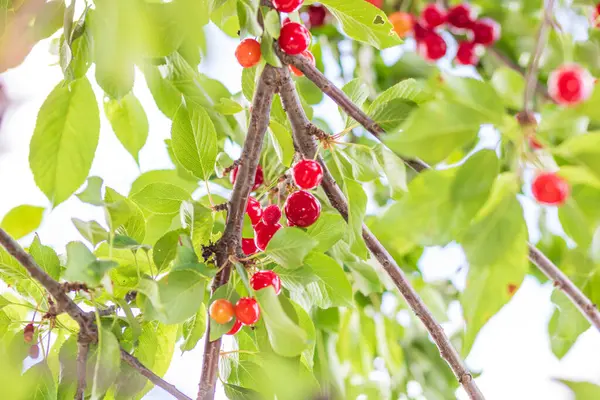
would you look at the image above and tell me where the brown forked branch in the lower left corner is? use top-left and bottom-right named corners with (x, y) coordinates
top-left (0, 228), bottom-right (191, 400)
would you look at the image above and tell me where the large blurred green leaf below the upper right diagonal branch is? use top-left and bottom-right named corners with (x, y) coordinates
top-left (383, 100), bottom-right (489, 164)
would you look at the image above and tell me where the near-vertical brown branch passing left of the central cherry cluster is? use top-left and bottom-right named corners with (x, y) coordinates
top-left (198, 65), bottom-right (280, 400)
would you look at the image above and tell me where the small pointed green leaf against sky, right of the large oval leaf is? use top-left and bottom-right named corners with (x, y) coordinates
top-left (104, 93), bottom-right (149, 164)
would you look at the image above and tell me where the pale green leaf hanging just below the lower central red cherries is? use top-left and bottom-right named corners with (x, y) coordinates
top-left (255, 286), bottom-right (308, 357)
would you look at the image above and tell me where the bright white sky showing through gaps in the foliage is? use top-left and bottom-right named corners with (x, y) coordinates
top-left (0, 21), bottom-right (600, 400)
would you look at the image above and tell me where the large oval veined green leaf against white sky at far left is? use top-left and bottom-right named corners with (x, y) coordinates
top-left (29, 78), bottom-right (100, 206)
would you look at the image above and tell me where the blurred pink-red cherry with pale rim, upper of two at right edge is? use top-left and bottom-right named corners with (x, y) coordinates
top-left (548, 64), bottom-right (594, 106)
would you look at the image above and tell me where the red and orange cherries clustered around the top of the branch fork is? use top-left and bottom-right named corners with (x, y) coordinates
top-left (235, 0), bottom-right (315, 76)
